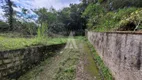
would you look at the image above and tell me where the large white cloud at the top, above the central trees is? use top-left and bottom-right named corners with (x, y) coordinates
top-left (12, 0), bottom-right (80, 10)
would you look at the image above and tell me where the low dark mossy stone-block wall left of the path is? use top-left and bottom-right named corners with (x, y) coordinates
top-left (0, 44), bottom-right (65, 80)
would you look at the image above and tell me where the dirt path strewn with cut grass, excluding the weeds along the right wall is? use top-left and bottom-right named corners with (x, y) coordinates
top-left (19, 39), bottom-right (101, 80)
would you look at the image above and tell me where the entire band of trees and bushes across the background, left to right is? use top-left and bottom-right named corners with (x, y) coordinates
top-left (0, 0), bottom-right (142, 33)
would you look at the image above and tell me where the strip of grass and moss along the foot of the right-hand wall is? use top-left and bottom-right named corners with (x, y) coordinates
top-left (76, 37), bottom-right (113, 80)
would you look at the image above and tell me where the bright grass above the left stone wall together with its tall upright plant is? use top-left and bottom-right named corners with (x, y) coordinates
top-left (0, 18), bottom-right (67, 51)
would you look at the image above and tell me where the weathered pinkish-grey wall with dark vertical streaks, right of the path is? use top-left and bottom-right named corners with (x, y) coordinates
top-left (86, 31), bottom-right (142, 80)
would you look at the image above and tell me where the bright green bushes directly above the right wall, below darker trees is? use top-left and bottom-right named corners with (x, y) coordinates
top-left (86, 7), bottom-right (138, 31)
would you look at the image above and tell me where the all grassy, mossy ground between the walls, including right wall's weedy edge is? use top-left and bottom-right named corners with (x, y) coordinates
top-left (18, 37), bottom-right (113, 80)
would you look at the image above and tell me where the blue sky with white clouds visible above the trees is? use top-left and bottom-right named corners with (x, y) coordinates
top-left (0, 0), bottom-right (80, 20)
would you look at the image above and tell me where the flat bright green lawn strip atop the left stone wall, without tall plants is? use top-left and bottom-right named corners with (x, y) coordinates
top-left (0, 36), bottom-right (67, 51)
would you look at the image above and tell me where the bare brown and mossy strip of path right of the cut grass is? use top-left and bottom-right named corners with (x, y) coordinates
top-left (76, 42), bottom-right (101, 80)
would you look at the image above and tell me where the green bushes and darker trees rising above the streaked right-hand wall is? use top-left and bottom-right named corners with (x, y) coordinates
top-left (82, 0), bottom-right (142, 32)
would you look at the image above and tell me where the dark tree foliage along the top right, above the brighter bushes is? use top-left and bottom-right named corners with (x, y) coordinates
top-left (81, 0), bottom-right (142, 11)
